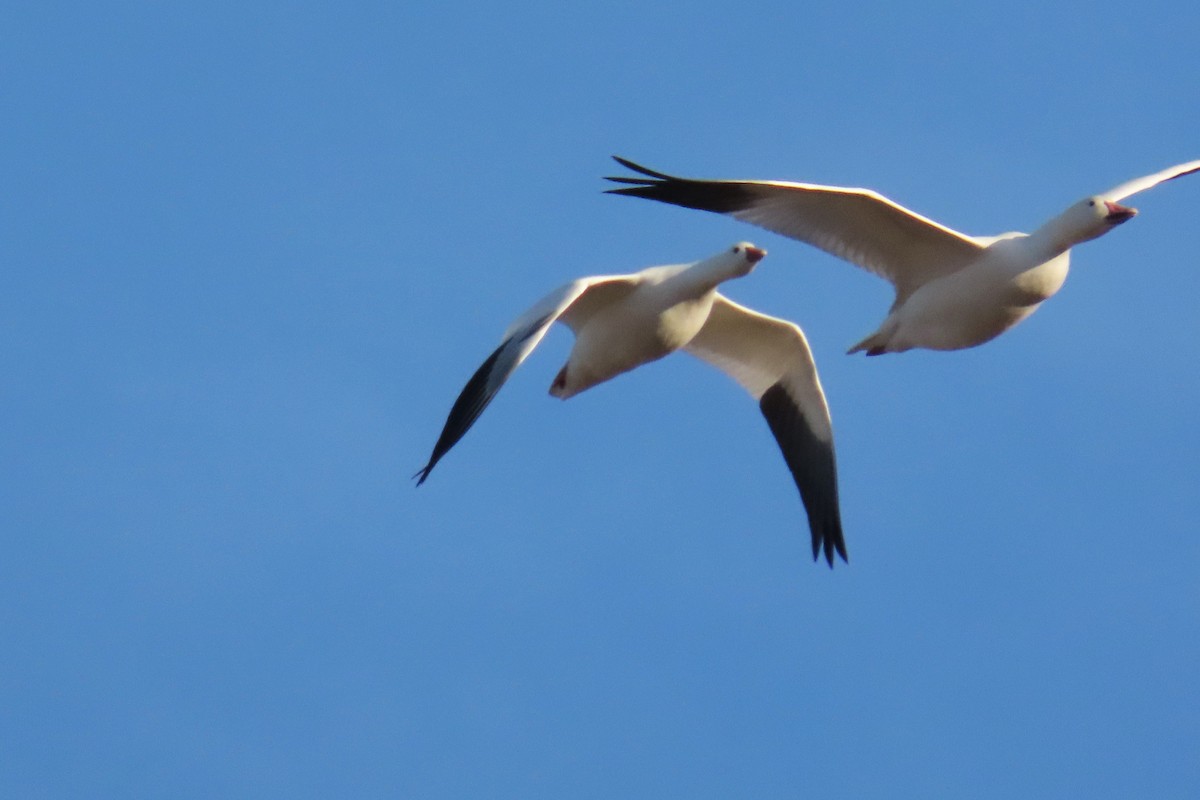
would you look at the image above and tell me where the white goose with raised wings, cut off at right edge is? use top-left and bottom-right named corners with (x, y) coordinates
top-left (607, 156), bottom-right (1200, 355)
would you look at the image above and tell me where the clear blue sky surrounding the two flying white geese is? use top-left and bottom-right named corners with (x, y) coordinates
top-left (0, 1), bottom-right (1200, 799)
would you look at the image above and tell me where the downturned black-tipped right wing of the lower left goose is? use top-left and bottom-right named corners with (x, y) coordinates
top-left (684, 294), bottom-right (846, 566)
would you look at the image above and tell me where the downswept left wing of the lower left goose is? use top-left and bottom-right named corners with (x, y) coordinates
top-left (413, 275), bottom-right (634, 486)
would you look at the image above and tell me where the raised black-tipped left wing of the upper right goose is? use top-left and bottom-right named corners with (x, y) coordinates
top-left (606, 156), bottom-right (984, 302)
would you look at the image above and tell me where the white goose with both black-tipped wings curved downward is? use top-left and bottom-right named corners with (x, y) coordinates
top-left (414, 242), bottom-right (846, 566)
